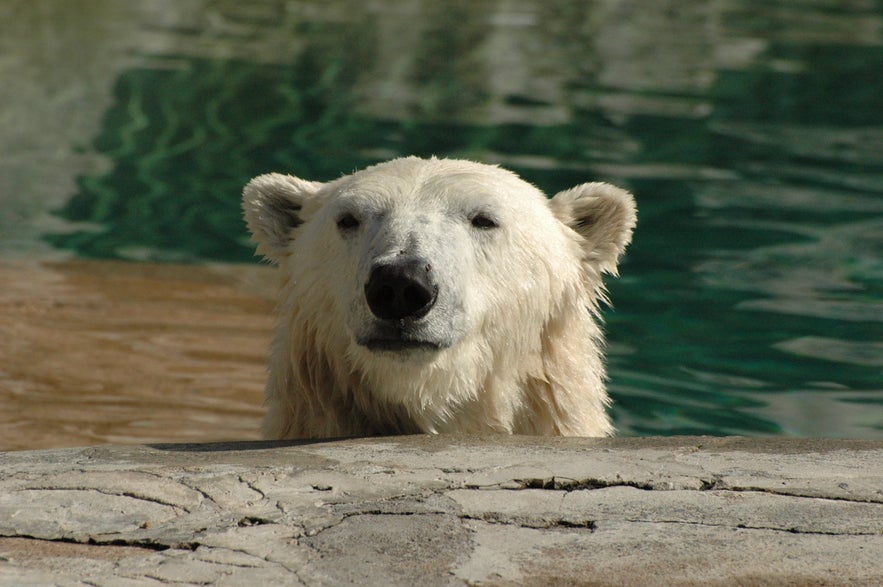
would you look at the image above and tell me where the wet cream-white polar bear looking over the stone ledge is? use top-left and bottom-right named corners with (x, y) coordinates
top-left (243, 157), bottom-right (636, 439)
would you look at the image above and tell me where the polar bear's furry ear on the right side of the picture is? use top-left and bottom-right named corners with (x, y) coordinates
top-left (549, 182), bottom-right (638, 275)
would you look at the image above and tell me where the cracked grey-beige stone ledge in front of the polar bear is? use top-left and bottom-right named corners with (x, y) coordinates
top-left (0, 436), bottom-right (883, 587)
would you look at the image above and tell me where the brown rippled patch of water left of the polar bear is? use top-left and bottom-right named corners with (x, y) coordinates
top-left (0, 260), bottom-right (274, 450)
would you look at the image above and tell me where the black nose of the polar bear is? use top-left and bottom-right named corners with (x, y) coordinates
top-left (365, 259), bottom-right (438, 320)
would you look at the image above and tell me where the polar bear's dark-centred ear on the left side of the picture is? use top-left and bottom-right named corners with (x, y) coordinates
top-left (242, 173), bottom-right (322, 263)
